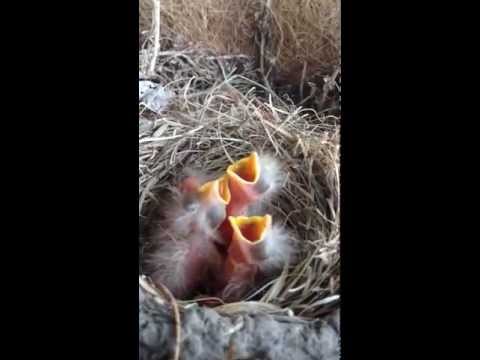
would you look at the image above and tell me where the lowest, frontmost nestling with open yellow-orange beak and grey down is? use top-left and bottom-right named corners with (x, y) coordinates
top-left (221, 215), bottom-right (294, 301)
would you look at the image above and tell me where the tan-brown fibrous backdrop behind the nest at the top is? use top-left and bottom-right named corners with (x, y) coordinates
top-left (140, 0), bottom-right (340, 84)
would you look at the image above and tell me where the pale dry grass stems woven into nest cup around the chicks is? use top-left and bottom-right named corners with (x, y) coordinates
top-left (139, 45), bottom-right (340, 317)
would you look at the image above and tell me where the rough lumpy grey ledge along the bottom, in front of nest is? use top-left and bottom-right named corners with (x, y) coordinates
top-left (139, 289), bottom-right (340, 360)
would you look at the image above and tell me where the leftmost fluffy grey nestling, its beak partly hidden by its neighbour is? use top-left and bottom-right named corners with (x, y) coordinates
top-left (150, 177), bottom-right (230, 299)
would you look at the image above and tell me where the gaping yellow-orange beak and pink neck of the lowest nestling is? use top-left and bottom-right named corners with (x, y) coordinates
top-left (225, 215), bottom-right (272, 279)
